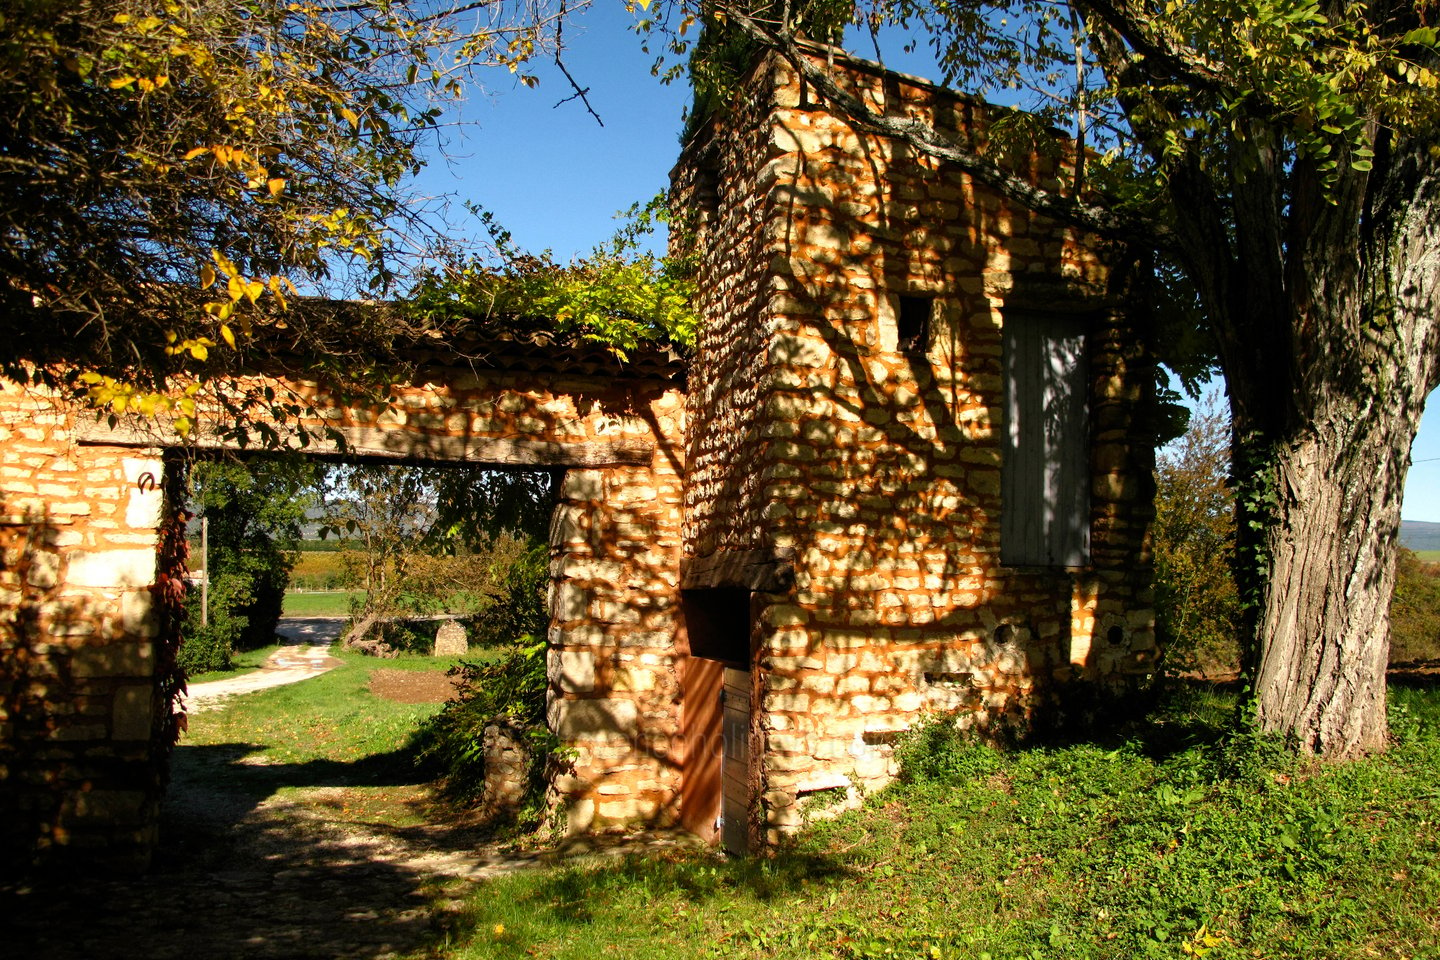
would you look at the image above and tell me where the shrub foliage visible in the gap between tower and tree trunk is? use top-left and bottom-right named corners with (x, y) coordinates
top-left (1153, 397), bottom-right (1241, 672)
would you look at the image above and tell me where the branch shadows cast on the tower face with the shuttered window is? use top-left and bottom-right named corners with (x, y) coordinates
top-left (769, 93), bottom-right (1145, 725)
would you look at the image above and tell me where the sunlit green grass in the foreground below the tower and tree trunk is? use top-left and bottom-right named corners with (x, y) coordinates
top-left (426, 689), bottom-right (1440, 960)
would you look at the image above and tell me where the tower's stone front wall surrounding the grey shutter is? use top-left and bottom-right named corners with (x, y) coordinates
top-left (681, 59), bottom-right (1153, 839)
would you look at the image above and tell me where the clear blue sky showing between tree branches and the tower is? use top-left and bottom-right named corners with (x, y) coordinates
top-left (419, 0), bottom-right (1440, 522)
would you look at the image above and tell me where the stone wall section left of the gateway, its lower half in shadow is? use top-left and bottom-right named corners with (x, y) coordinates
top-left (0, 381), bottom-right (164, 865)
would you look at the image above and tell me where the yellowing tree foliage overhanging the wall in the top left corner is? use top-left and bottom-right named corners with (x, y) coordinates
top-left (0, 0), bottom-right (557, 408)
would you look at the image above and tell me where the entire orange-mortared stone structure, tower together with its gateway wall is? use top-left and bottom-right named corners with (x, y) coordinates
top-left (0, 46), bottom-right (1155, 864)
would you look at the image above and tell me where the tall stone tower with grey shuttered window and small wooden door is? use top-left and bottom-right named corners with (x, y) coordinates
top-left (674, 48), bottom-right (1155, 846)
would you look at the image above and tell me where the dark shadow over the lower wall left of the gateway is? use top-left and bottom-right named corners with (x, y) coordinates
top-left (0, 505), bottom-right (157, 864)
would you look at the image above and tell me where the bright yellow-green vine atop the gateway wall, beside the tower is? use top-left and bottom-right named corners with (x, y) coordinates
top-left (405, 197), bottom-right (697, 357)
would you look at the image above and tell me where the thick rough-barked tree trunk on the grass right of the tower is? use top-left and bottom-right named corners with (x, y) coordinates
top-left (1221, 142), bottom-right (1440, 759)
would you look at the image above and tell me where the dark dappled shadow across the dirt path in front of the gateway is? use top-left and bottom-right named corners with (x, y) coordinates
top-left (0, 744), bottom-right (485, 960)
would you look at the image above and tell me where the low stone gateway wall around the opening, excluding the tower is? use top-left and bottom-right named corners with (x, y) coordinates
top-left (0, 367), bottom-right (684, 868)
